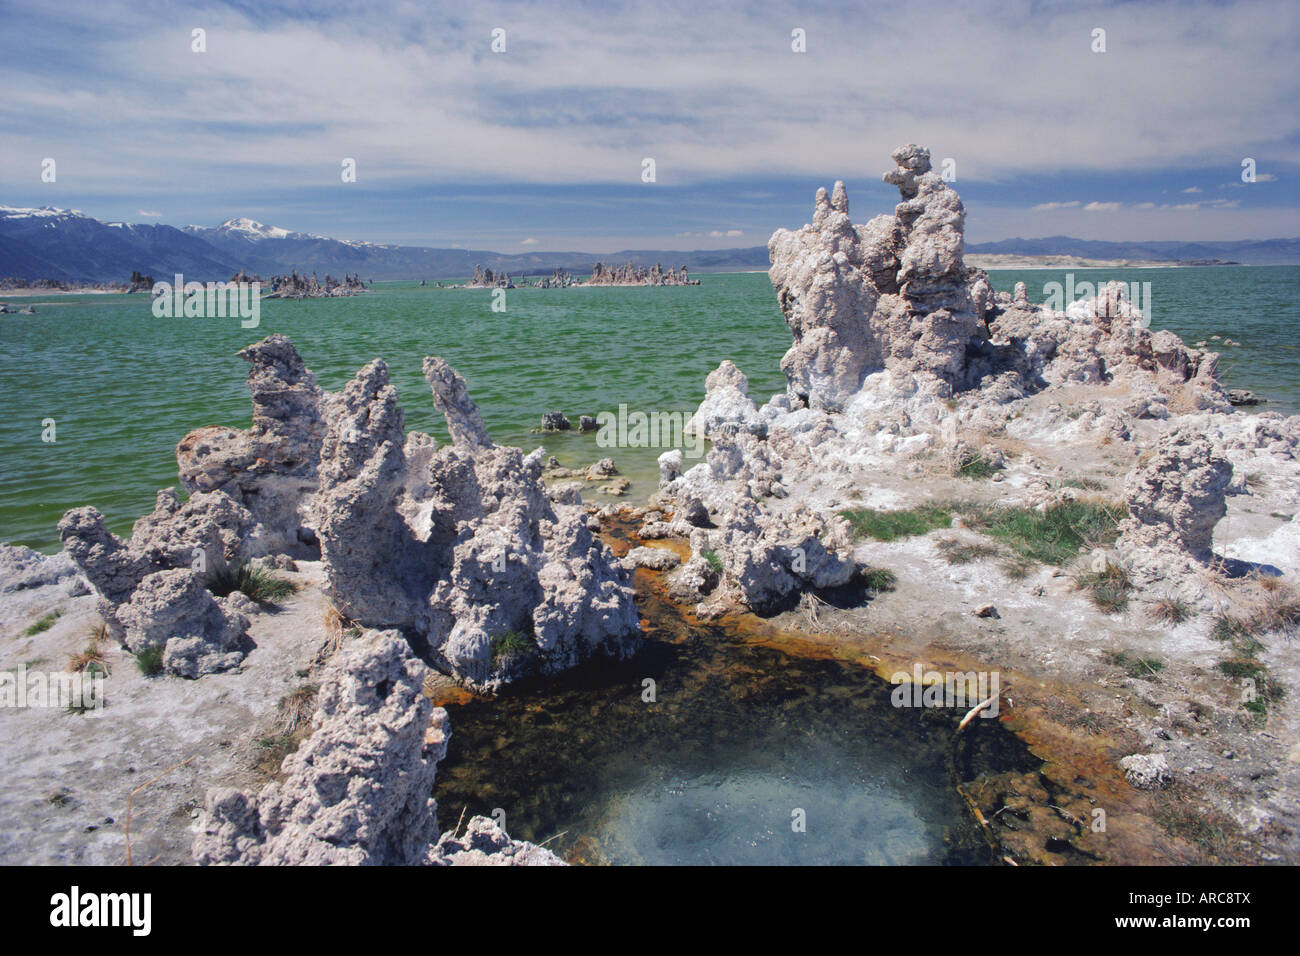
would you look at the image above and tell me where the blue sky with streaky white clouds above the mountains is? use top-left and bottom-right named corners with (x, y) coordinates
top-left (0, 0), bottom-right (1300, 252)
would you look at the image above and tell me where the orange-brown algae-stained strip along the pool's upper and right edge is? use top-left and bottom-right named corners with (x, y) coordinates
top-left (593, 512), bottom-right (1196, 865)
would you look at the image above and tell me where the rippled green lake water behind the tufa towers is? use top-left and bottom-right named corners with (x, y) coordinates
top-left (0, 267), bottom-right (1300, 550)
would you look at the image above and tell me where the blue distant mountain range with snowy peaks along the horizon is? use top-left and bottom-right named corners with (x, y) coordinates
top-left (0, 206), bottom-right (1300, 282)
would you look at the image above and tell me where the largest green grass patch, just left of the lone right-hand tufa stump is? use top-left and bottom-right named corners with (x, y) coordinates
top-left (970, 501), bottom-right (1126, 566)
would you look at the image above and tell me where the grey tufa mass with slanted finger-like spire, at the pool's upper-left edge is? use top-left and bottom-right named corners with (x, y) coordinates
top-left (317, 348), bottom-right (640, 689)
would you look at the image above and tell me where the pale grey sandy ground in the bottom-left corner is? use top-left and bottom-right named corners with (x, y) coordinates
top-left (0, 562), bottom-right (328, 865)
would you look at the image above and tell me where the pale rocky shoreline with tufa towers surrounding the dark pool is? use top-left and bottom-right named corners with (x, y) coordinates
top-left (0, 146), bottom-right (1300, 864)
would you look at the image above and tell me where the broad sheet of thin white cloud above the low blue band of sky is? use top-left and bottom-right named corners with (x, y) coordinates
top-left (0, 0), bottom-right (1300, 193)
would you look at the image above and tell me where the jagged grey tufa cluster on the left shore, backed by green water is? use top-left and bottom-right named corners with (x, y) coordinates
top-left (60, 336), bottom-right (638, 688)
